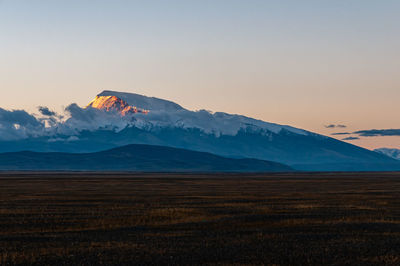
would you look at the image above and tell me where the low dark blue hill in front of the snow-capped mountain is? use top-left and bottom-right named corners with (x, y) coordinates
top-left (0, 144), bottom-right (293, 172)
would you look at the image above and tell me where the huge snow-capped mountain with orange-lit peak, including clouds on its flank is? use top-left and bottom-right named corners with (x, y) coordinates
top-left (0, 91), bottom-right (400, 171)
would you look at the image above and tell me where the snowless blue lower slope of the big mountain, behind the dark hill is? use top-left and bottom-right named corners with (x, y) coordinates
top-left (1, 127), bottom-right (400, 171)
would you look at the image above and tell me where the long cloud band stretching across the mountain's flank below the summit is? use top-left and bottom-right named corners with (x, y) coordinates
top-left (0, 97), bottom-right (343, 142)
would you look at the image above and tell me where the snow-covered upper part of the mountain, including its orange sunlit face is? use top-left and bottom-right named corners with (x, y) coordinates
top-left (88, 91), bottom-right (310, 136)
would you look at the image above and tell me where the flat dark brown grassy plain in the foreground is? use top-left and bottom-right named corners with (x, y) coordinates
top-left (0, 173), bottom-right (400, 265)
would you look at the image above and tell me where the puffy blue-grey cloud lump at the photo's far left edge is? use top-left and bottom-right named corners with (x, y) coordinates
top-left (0, 108), bottom-right (45, 140)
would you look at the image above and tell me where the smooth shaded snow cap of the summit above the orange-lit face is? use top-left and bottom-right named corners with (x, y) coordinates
top-left (97, 90), bottom-right (184, 111)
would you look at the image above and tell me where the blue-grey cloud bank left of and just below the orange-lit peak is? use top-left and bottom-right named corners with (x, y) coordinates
top-left (0, 103), bottom-right (137, 142)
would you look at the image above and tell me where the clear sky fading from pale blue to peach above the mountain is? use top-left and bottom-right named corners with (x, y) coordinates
top-left (0, 0), bottom-right (400, 149)
